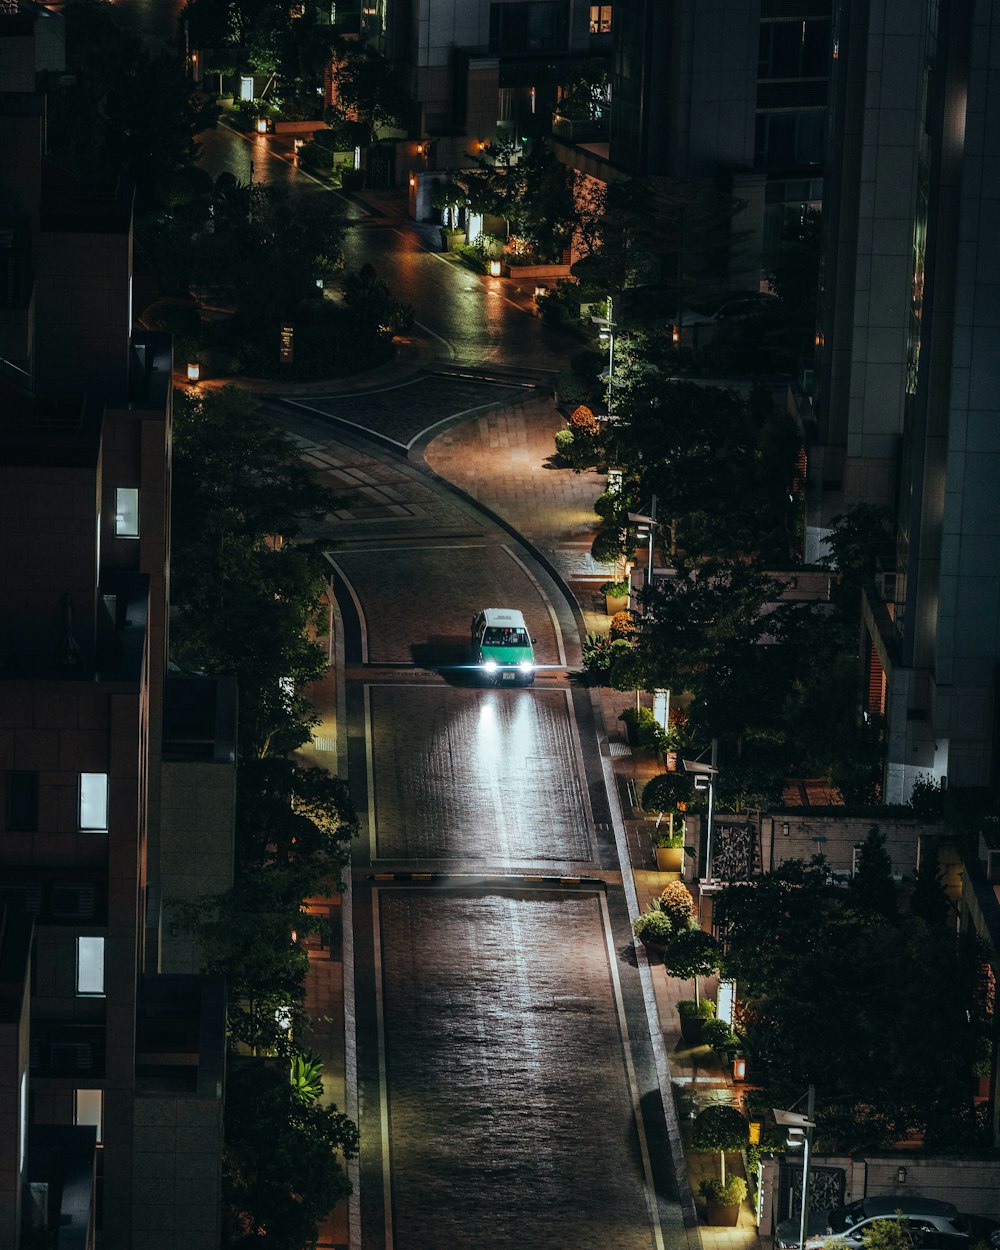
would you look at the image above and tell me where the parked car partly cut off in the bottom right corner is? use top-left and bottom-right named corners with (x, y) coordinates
top-left (774, 1194), bottom-right (1000, 1250)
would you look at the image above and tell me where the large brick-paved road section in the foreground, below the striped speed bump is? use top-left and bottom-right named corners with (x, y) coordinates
top-left (380, 890), bottom-right (655, 1250)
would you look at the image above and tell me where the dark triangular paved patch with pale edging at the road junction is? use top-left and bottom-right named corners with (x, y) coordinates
top-left (287, 375), bottom-right (526, 448)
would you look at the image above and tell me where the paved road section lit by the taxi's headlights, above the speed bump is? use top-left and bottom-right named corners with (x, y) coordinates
top-left (369, 686), bottom-right (594, 866)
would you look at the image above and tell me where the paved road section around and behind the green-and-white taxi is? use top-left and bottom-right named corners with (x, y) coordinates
top-left (331, 546), bottom-right (559, 666)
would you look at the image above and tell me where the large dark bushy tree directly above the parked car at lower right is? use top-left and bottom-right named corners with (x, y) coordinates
top-left (715, 856), bottom-right (991, 1149)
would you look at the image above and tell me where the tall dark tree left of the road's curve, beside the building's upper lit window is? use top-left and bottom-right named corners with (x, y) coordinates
top-left (171, 388), bottom-right (338, 758)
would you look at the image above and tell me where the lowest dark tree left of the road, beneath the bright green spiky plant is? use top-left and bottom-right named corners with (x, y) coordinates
top-left (223, 1060), bottom-right (359, 1250)
